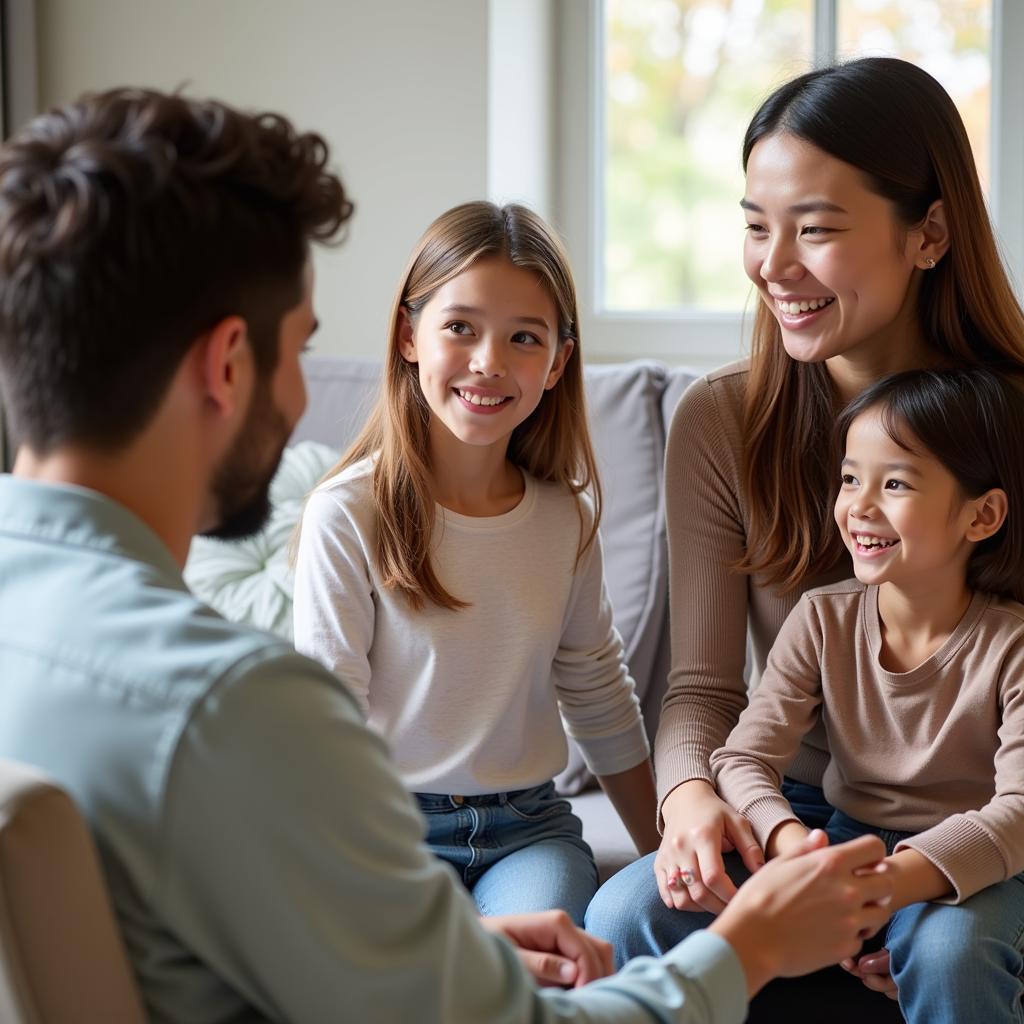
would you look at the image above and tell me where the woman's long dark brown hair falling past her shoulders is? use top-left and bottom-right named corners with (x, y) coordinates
top-left (736, 57), bottom-right (1024, 590)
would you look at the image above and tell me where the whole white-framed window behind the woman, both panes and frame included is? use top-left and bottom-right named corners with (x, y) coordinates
top-left (553, 0), bottom-right (1024, 367)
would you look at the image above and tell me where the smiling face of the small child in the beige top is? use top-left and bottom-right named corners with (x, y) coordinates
top-left (836, 410), bottom-right (975, 587)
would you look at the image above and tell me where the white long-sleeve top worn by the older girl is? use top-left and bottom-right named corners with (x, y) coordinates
top-left (294, 460), bottom-right (648, 796)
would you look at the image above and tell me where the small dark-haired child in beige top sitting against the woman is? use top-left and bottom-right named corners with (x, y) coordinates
top-left (708, 370), bottom-right (1024, 1024)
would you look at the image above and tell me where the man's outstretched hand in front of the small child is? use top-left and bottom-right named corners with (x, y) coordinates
top-left (711, 829), bottom-right (893, 996)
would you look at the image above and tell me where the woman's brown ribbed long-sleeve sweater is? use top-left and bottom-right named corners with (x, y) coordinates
top-left (654, 362), bottom-right (853, 803)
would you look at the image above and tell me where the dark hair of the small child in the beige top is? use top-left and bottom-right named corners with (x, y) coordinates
top-left (836, 369), bottom-right (1024, 602)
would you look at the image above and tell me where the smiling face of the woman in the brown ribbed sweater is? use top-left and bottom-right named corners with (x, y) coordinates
top-left (741, 133), bottom-right (924, 373)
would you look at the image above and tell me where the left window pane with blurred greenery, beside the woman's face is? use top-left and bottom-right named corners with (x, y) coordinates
top-left (597, 0), bottom-right (813, 312)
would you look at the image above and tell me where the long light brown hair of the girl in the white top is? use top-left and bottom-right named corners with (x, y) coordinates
top-left (315, 202), bottom-right (601, 609)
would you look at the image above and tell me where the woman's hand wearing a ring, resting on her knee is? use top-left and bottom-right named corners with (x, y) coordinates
top-left (654, 779), bottom-right (765, 913)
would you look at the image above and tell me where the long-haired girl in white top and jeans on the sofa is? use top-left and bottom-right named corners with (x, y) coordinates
top-left (295, 197), bottom-right (657, 924)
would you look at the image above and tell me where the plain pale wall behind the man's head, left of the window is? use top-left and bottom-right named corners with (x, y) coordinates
top-left (36, 0), bottom-right (487, 357)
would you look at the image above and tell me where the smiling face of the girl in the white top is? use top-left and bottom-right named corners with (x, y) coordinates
top-left (401, 257), bottom-right (572, 445)
